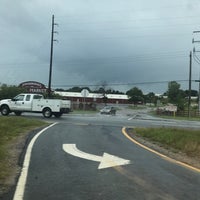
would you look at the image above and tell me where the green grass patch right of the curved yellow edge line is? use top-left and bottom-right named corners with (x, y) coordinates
top-left (134, 128), bottom-right (200, 156)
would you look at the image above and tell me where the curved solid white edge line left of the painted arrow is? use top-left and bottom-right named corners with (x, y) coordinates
top-left (13, 122), bottom-right (57, 200)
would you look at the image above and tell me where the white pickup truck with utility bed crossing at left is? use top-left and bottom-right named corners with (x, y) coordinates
top-left (0, 94), bottom-right (71, 118)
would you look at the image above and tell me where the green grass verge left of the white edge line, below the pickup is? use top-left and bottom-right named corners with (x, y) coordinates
top-left (0, 116), bottom-right (46, 182)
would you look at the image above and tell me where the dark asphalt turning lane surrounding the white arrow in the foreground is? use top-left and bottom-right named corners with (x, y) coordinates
top-left (16, 116), bottom-right (200, 200)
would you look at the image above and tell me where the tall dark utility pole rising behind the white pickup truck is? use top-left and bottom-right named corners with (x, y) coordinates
top-left (48, 15), bottom-right (58, 98)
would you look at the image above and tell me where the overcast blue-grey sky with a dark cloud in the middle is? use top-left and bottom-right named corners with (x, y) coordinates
top-left (0, 0), bottom-right (200, 93)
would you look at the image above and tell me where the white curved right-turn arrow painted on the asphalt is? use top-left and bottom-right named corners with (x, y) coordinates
top-left (63, 144), bottom-right (130, 169)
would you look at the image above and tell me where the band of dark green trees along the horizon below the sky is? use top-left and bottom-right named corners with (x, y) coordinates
top-left (0, 81), bottom-right (198, 110)
